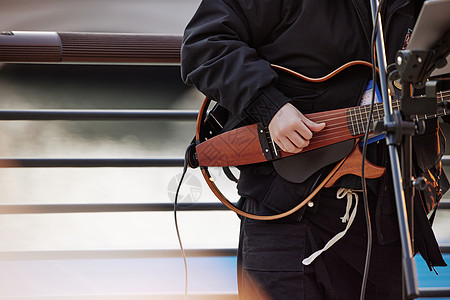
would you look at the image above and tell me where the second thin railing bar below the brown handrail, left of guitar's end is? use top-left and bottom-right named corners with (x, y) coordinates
top-left (0, 158), bottom-right (184, 168)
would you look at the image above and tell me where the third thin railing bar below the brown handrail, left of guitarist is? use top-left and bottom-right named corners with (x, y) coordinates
top-left (0, 202), bottom-right (232, 215)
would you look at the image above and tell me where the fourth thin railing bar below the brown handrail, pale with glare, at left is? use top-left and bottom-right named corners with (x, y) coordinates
top-left (0, 248), bottom-right (237, 261)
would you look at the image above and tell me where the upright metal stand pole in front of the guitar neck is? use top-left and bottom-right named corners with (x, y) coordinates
top-left (371, 0), bottom-right (419, 299)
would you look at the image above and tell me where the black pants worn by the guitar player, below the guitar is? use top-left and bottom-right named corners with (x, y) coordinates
top-left (238, 189), bottom-right (402, 300)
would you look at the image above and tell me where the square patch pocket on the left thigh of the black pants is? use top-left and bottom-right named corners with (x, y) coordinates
top-left (242, 221), bottom-right (306, 272)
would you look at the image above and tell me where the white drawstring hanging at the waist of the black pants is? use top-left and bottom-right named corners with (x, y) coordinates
top-left (302, 188), bottom-right (359, 265)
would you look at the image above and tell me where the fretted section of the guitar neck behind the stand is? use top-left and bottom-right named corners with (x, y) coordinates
top-left (347, 90), bottom-right (450, 136)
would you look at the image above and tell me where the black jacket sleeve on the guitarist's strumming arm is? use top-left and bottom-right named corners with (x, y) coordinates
top-left (181, 0), bottom-right (290, 125)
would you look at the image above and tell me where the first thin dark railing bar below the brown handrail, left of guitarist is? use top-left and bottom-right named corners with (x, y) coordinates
top-left (0, 109), bottom-right (198, 121)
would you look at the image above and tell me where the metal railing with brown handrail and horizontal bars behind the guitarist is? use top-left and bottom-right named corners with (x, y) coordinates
top-left (0, 32), bottom-right (450, 299)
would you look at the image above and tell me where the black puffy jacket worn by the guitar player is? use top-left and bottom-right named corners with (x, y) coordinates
top-left (181, 0), bottom-right (448, 265)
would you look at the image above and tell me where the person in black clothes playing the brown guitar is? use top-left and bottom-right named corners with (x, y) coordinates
top-left (181, 0), bottom-right (449, 299)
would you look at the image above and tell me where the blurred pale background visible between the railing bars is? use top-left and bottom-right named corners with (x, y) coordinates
top-left (0, 0), bottom-right (450, 299)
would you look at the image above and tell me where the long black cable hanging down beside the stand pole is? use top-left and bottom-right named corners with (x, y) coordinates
top-left (360, 0), bottom-right (384, 300)
